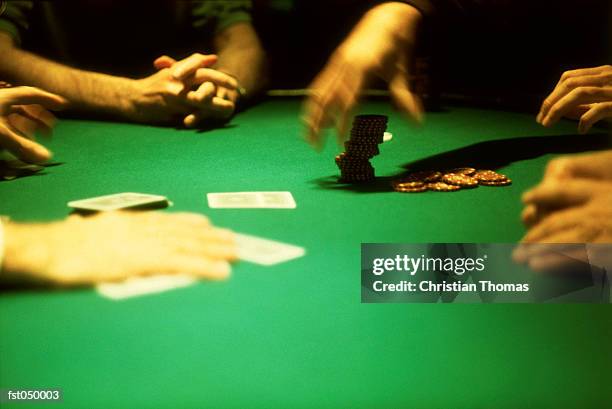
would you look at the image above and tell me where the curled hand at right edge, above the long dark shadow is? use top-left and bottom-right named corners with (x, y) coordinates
top-left (536, 65), bottom-right (612, 134)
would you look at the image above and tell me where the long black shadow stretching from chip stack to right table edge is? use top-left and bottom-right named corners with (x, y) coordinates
top-left (313, 133), bottom-right (612, 193)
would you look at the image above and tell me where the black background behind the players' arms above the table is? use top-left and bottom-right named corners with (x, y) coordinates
top-left (17, 0), bottom-right (612, 110)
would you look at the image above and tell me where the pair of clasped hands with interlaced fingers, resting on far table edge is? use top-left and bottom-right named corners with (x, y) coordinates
top-left (127, 53), bottom-right (238, 127)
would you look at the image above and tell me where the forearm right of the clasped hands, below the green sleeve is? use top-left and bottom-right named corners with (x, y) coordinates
top-left (215, 23), bottom-right (267, 96)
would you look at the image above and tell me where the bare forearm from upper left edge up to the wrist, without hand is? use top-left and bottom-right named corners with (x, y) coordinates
top-left (0, 33), bottom-right (133, 117)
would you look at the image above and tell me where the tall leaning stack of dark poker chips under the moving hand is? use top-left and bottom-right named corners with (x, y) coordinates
top-left (336, 115), bottom-right (387, 183)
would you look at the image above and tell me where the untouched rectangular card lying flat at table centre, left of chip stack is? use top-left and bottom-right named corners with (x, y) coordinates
top-left (206, 192), bottom-right (296, 209)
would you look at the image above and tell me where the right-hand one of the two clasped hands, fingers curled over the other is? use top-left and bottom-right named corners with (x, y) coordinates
top-left (153, 54), bottom-right (239, 127)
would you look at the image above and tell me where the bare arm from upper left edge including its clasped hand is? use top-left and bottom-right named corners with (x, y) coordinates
top-left (0, 32), bottom-right (233, 124)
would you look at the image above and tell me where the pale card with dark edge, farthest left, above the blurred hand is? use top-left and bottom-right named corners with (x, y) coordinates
top-left (68, 193), bottom-right (169, 212)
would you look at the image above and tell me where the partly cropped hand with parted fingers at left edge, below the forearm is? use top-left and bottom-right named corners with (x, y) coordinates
top-left (0, 87), bottom-right (67, 163)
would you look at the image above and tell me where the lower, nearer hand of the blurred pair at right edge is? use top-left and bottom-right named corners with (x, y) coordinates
top-left (513, 183), bottom-right (612, 272)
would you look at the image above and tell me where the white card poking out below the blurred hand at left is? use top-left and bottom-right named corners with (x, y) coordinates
top-left (96, 274), bottom-right (197, 300)
